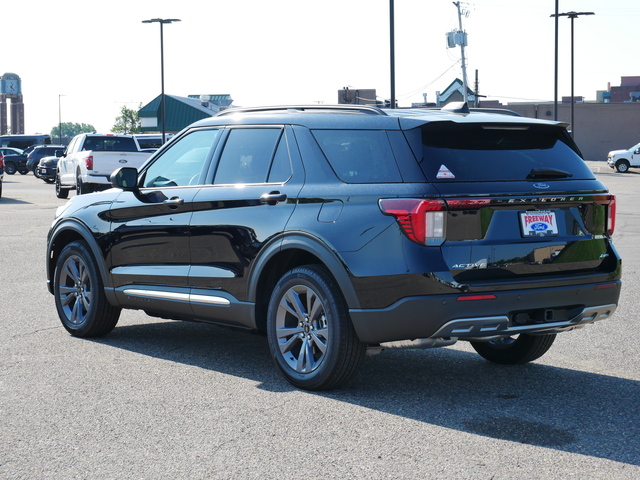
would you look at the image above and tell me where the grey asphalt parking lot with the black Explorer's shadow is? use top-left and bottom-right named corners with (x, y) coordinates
top-left (0, 166), bottom-right (640, 480)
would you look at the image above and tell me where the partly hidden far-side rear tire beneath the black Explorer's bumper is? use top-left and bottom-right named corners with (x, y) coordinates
top-left (471, 333), bottom-right (556, 365)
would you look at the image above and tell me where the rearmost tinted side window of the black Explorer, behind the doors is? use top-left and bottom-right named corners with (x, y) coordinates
top-left (313, 130), bottom-right (402, 183)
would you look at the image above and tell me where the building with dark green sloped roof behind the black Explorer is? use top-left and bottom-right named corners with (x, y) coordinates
top-left (138, 94), bottom-right (233, 133)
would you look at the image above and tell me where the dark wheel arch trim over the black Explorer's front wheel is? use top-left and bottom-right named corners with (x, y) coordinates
top-left (46, 220), bottom-right (111, 295)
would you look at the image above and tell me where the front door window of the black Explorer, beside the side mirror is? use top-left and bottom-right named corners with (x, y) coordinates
top-left (142, 129), bottom-right (220, 188)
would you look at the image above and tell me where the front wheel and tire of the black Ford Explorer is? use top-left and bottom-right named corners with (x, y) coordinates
top-left (53, 241), bottom-right (121, 338)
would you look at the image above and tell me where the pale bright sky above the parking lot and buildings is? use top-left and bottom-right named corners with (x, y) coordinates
top-left (0, 0), bottom-right (640, 134)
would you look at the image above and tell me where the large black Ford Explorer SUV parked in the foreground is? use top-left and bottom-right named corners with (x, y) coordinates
top-left (46, 105), bottom-right (621, 390)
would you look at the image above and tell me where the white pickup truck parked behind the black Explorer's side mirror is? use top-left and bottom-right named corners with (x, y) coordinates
top-left (56, 133), bottom-right (151, 198)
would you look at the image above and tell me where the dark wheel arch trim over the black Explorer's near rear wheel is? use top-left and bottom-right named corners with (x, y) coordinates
top-left (247, 233), bottom-right (360, 331)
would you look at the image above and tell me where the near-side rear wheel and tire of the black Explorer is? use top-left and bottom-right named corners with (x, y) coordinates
top-left (267, 265), bottom-right (366, 390)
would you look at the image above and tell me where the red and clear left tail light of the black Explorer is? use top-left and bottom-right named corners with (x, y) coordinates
top-left (379, 198), bottom-right (447, 246)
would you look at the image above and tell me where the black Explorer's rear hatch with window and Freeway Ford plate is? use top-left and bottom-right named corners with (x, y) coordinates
top-left (400, 121), bottom-right (619, 289)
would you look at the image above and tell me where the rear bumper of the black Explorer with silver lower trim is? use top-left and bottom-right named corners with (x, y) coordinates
top-left (350, 280), bottom-right (621, 344)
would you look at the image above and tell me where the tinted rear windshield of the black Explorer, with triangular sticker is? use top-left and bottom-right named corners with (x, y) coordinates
top-left (418, 123), bottom-right (594, 182)
